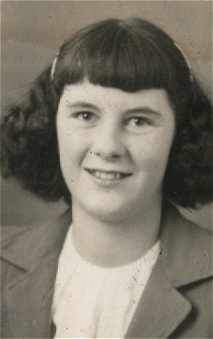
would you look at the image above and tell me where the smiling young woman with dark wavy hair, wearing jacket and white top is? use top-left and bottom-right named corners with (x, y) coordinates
top-left (2, 19), bottom-right (212, 338)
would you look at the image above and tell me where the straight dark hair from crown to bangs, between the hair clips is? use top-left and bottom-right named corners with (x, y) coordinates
top-left (54, 19), bottom-right (188, 92)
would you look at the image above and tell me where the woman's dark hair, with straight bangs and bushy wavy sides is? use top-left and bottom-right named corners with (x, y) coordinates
top-left (1, 18), bottom-right (213, 208)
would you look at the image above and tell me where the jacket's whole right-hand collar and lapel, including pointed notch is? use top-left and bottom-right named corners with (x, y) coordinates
top-left (125, 206), bottom-right (212, 338)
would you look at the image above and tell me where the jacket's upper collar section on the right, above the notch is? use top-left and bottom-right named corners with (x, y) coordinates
top-left (161, 208), bottom-right (212, 286)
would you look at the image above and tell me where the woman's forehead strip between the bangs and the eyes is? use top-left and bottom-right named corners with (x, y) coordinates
top-left (60, 80), bottom-right (173, 112)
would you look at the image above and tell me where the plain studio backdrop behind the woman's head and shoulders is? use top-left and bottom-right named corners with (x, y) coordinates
top-left (1, 1), bottom-right (212, 229)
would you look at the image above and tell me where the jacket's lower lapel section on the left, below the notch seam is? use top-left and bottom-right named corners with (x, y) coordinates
top-left (6, 251), bottom-right (59, 338)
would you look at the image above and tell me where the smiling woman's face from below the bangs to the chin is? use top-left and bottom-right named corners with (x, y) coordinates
top-left (57, 80), bottom-right (175, 221)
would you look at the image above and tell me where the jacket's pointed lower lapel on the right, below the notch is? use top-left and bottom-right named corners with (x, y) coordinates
top-left (125, 265), bottom-right (191, 338)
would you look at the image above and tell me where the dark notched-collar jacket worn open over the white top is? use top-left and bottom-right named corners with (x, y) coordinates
top-left (1, 207), bottom-right (212, 338)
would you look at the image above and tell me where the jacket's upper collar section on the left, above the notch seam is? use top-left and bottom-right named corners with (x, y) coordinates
top-left (1, 211), bottom-right (71, 270)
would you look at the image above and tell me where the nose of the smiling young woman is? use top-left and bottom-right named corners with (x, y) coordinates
top-left (91, 125), bottom-right (126, 160)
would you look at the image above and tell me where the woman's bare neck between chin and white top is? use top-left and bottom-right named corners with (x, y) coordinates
top-left (72, 201), bottom-right (162, 266)
